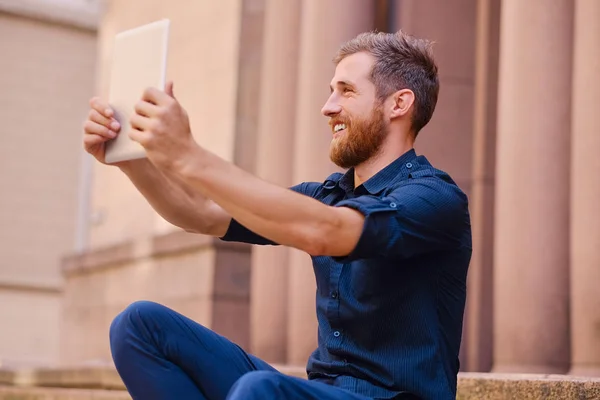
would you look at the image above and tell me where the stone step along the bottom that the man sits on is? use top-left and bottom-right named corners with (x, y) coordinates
top-left (0, 366), bottom-right (600, 400)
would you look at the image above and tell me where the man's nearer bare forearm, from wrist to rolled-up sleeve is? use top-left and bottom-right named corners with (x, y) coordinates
top-left (177, 149), bottom-right (362, 255)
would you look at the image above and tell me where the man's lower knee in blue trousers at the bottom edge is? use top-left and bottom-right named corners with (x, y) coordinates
top-left (227, 371), bottom-right (285, 400)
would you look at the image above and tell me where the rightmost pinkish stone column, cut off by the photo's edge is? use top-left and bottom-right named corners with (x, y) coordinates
top-left (570, 0), bottom-right (600, 376)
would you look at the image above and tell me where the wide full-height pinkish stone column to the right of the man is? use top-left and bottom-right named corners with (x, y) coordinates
top-left (494, 0), bottom-right (573, 373)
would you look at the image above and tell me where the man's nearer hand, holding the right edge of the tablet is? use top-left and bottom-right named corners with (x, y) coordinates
top-left (129, 82), bottom-right (198, 170)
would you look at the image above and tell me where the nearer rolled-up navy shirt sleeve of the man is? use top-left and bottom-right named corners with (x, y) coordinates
top-left (335, 177), bottom-right (470, 262)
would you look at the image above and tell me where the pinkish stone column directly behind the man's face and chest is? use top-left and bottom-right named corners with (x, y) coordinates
top-left (287, 0), bottom-right (374, 365)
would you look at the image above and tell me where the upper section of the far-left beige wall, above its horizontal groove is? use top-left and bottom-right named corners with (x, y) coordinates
top-left (0, 14), bottom-right (96, 286)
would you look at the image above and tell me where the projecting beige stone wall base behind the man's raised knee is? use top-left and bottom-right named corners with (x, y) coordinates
top-left (60, 245), bottom-right (214, 365)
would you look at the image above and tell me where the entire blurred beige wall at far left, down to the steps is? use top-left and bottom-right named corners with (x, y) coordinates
top-left (0, 8), bottom-right (96, 364)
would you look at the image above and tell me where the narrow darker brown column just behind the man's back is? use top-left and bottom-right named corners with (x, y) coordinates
top-left (464, 0), bottom-right (500, 372)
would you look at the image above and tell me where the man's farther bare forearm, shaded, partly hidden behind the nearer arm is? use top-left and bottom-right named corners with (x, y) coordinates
top-left (119, 159), bottom-right (226, 236)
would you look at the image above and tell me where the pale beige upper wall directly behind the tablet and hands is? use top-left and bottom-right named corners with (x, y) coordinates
top-left (90, 0), bottom-right (241, 248)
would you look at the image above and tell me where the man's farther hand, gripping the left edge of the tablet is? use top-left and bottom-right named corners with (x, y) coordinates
top-left (83, 97), bottom-right (121, 164)
